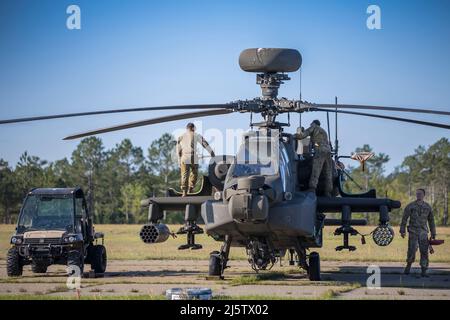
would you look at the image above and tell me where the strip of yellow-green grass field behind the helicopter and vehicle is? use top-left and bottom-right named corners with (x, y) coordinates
top-left (0, 225), bottom-right (450, 262)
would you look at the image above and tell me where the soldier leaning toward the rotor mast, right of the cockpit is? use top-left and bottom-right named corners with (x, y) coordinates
top-left (294, 120), bottom-right (333, 197)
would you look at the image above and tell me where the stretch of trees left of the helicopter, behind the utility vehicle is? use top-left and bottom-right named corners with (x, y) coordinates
top-left (0, 133), bottom-right (179, 223)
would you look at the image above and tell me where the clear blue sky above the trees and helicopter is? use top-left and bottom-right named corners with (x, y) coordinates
top-left (0, 0), bottom-right (450, 171)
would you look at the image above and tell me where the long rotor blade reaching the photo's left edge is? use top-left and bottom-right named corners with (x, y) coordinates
top-left (0, 104), bottom-right (233, 124)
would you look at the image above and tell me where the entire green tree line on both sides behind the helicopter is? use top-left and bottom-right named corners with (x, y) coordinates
top-left (0, 133), bottom-right (450, 225)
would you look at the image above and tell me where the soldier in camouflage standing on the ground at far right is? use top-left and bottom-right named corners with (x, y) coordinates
top-left (400, 189), bottom-right (436, 277)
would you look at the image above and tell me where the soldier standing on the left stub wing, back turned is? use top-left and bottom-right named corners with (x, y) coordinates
top-left (177, 122), bottom-right (214, 197)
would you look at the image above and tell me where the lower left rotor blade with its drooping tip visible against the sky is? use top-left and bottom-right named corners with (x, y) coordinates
top-left (63, 109), bottom-right (233, 140)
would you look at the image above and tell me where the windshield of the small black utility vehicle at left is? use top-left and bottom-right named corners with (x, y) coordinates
top-left (18, 195), bottom-right (74, 232)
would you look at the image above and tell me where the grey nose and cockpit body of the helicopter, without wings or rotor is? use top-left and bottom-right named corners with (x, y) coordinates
top-left (201, 130), bottom-right (322, 251)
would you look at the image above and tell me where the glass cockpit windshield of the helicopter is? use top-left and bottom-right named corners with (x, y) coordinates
top-left (230, 136), bottom-right (279, 178)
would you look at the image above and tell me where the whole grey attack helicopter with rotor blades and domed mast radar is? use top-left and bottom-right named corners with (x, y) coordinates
top-left (0, 48), bottom-right (450, 281)
